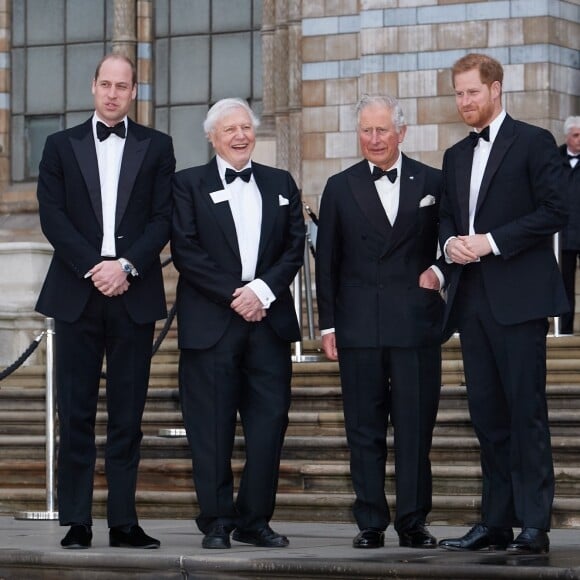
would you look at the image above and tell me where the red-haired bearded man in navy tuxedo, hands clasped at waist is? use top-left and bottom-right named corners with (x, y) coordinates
top-left (440, 54), bottom-right (568, 553)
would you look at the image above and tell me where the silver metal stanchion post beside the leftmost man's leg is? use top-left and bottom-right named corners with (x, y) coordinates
top-left (14, 318), bottom-right (58, 520)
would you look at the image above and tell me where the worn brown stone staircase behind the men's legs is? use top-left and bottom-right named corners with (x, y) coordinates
top-left (0, 329), bottom-right (580, 527)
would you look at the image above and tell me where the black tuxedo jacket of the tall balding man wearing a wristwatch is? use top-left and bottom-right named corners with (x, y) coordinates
top-left (36, 119), bottom-right (175, 323)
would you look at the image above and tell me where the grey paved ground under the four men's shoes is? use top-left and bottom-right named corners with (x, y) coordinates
top-left (0, 517), bottom-right (580, 580)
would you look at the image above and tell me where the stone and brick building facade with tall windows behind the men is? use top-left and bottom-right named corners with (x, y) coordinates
top-left (0, 0), bottom-right (580, 220)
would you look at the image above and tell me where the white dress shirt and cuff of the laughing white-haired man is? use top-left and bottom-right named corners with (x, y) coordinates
top-left (216, 155), bottom-right (276, 308)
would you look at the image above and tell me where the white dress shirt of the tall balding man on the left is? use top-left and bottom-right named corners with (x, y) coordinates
top-left (93, 113), bottom-right (127, 258)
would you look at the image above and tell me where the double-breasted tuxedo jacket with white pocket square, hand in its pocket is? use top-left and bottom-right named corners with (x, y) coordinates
top-left (316, 155), bottom-right (446, 347)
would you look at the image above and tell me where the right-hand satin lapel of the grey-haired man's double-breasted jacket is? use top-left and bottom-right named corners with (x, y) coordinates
top-left (387, 155), bottom-right (429, 251)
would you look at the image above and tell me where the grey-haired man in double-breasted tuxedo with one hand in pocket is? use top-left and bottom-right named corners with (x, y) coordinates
top-left (316, 95), bottom-right (444, 548)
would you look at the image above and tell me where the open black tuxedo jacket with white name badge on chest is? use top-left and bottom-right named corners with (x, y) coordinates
top-left (171, 157), bottom-right (305, 349)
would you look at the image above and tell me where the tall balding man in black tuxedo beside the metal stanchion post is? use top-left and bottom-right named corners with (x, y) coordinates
top-left (36, 54), bottom-right (175, 548)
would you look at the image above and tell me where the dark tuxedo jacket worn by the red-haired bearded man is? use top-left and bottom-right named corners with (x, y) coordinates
top-left (440, 115), bottom-right (569, 332)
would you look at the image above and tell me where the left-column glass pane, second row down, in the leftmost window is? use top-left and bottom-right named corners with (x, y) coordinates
top-left (26, 46), bottom-right (64, 114)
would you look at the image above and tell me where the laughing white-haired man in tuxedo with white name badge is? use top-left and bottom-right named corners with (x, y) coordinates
top-left (171, 99), bottom-right (305, 548)
